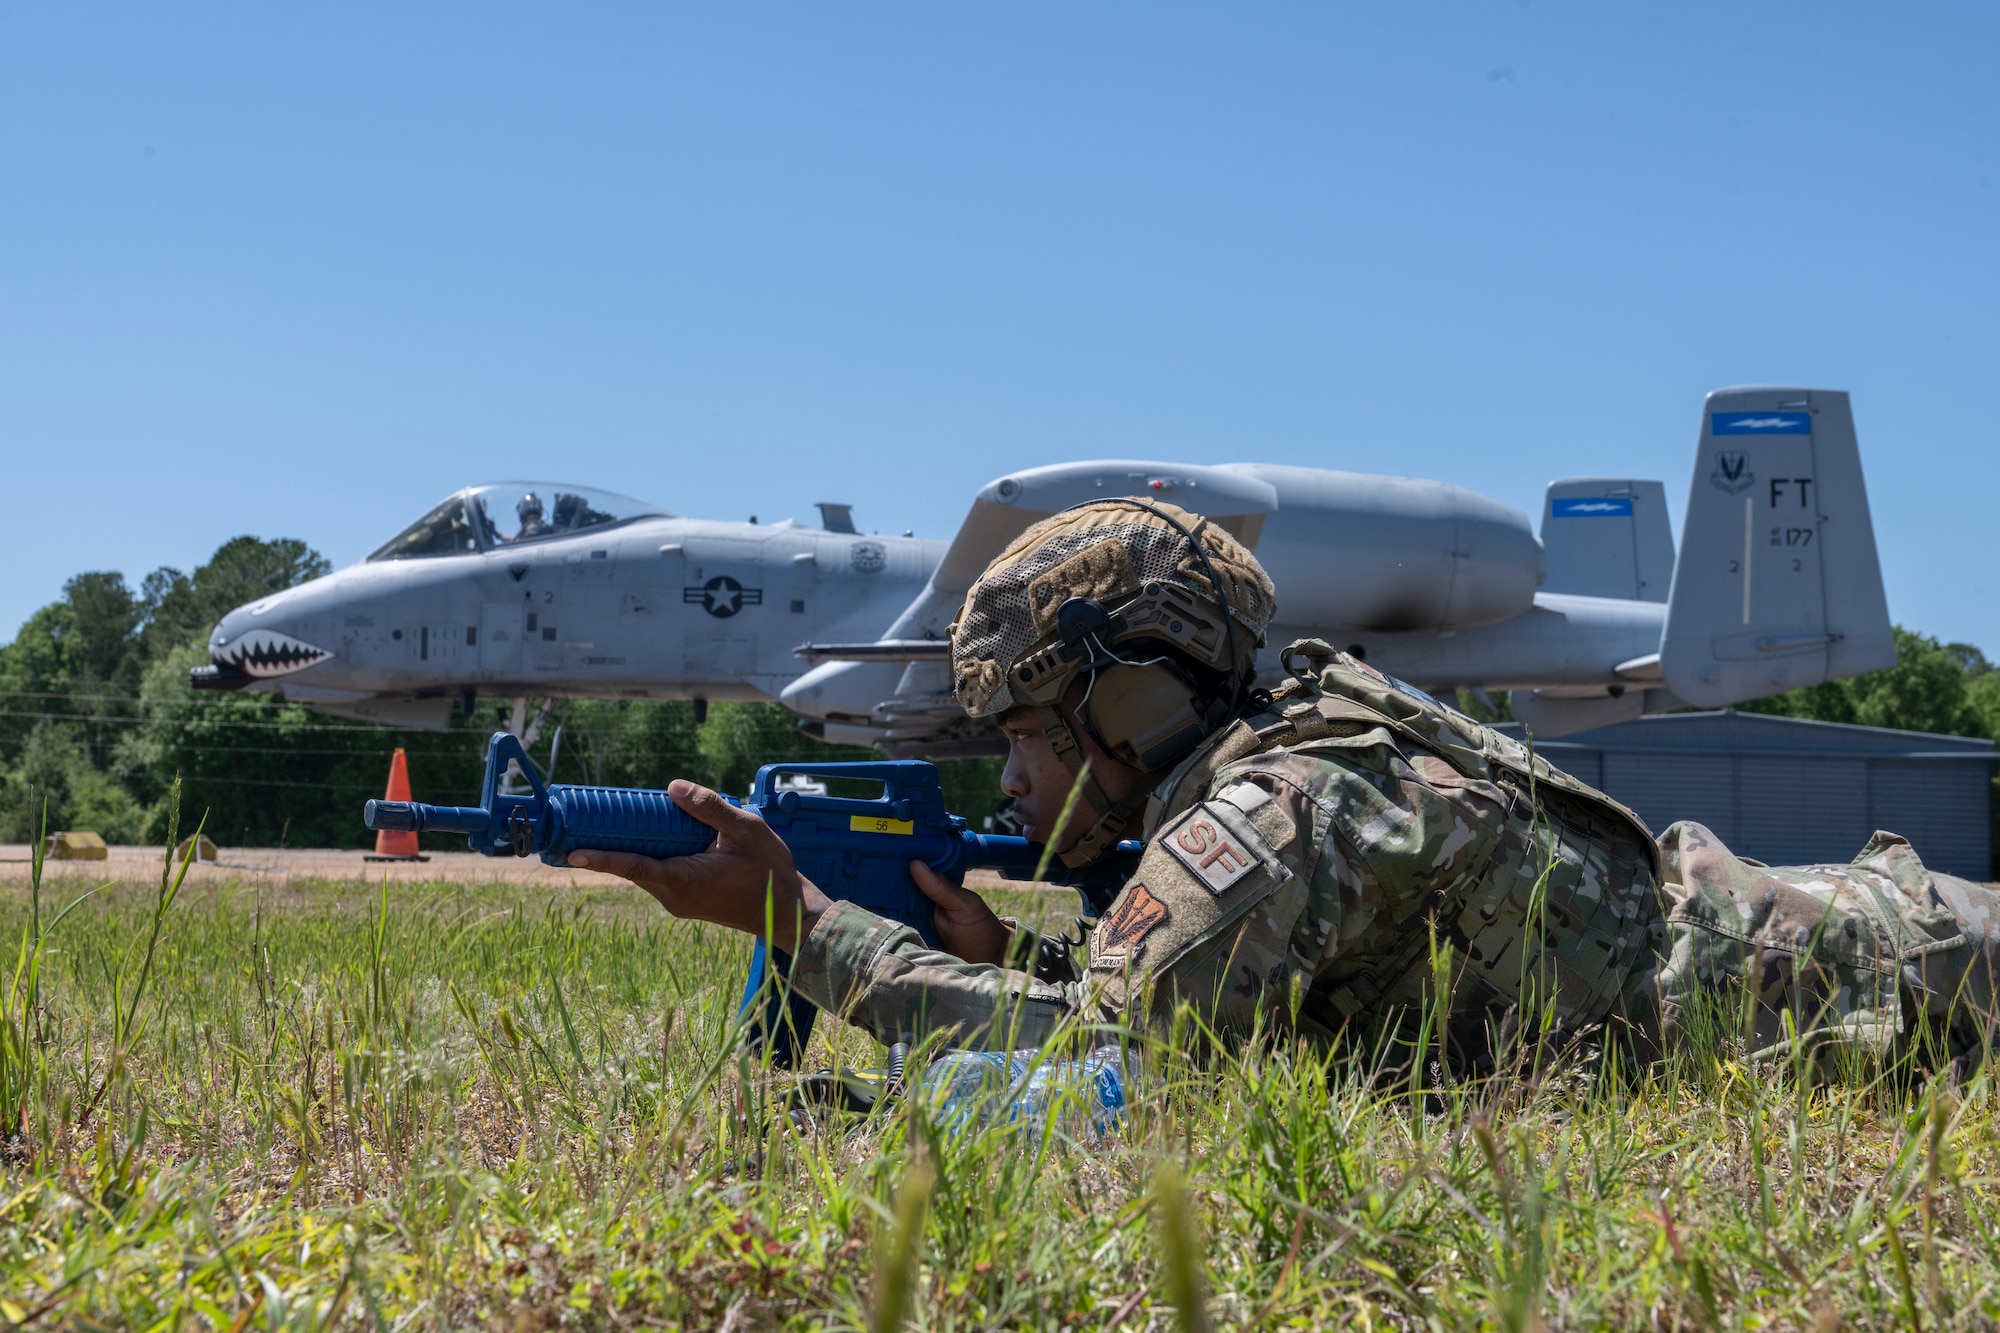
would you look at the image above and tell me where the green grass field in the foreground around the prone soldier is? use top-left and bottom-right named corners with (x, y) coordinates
top-left (0, 836), bottom-right (2000, 1331)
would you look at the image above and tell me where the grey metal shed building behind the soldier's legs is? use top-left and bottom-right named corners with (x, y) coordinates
top-left (1500, 709), bottom-right (1996, 881)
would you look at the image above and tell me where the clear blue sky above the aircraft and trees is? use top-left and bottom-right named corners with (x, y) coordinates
top-left (0, 0), bottom-right (2000, 654)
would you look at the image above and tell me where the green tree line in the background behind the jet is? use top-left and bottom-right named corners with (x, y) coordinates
top-left (0, 536), bottom-right (2000, 849)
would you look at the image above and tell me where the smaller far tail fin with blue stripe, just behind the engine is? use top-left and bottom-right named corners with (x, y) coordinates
top-left (1542, 476), bottom-right (1674, 602)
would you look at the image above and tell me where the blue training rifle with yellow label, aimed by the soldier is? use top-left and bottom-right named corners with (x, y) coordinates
top-left (362, 733), bottom-right (1140, 1069)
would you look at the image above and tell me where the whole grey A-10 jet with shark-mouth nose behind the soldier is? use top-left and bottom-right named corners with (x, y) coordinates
top-left (194, 388), bottom-right (1896, 740)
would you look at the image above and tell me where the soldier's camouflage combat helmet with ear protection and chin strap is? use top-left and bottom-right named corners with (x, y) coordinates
top-left (952, 498), bottom-right (1276, 867)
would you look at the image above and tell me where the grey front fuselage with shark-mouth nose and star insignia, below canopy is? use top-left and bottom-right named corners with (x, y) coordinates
top-left (210, 504), bottom-right (944, 723)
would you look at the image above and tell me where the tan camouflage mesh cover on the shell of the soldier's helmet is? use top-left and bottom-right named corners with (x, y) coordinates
top-left (952, 500), bottom-right (1276, 717)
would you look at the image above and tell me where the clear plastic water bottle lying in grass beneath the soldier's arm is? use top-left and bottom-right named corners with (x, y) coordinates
top-left (922, 1045), bottom-right (1134, 1133)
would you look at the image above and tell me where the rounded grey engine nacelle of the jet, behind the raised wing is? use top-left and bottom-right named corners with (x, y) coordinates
top-left (1228, 462), bottom-right (1544, 632)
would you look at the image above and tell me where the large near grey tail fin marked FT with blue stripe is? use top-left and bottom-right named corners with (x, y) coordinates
top-left (1660, 386), bottom-right (1896, 707)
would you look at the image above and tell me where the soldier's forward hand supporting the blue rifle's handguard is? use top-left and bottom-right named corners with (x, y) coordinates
top-left (570, 779), bottom-right (832, 953)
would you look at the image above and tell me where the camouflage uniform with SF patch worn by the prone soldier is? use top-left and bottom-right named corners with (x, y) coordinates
top-left (796, 640), bottom-right (2000, 1059)
